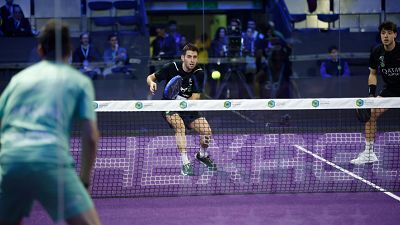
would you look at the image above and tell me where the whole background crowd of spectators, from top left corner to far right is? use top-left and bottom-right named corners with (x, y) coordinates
top-left (0, 0), bottom-right (356, 98)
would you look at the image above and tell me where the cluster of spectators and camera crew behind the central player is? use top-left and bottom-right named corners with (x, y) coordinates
top-left (150, 18), bottom-right (292, 98)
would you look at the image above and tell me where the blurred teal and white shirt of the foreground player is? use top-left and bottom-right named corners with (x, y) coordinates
top-left (0, 60), bottom-right (96, 165)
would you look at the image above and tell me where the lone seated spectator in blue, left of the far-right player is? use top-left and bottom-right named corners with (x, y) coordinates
top-left (319, 46), bottom-right (350, 77)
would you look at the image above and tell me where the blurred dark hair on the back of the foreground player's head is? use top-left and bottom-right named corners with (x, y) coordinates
top-left (38, 19), bottom-right (72, 60)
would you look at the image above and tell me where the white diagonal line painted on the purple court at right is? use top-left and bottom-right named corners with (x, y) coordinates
top-left (294, 145), bottom-right (400, 201)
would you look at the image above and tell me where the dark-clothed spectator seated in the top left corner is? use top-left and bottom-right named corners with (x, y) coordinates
top-left (4, 5), bottom-right (32, 37)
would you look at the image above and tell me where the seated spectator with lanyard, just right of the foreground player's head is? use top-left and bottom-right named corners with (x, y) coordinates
top-left (72, 32), bottom-right (101, 79)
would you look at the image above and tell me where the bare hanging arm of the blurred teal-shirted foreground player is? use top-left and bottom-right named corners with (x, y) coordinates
top-left (80, 120), bottom-right (99, 188)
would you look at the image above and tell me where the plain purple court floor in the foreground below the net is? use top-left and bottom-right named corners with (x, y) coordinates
top-left (24, 192), bottom-right (400, 225)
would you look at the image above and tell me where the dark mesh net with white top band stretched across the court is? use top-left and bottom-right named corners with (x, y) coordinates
top-left (71, 98), bottom-right (400, 197)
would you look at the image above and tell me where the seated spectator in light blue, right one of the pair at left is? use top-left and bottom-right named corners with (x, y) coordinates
top-left (103, 34), bottom-right (130, 76)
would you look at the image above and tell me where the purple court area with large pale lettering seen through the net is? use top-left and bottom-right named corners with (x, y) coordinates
top-left (72, 132), bottom-right (400, 198)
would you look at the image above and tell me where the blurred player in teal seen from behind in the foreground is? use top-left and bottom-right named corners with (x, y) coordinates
top-left (0, 20), bottom-right (100, 225)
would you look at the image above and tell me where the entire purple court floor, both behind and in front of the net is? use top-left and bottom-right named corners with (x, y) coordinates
top-left (24, 118), bottom-right (400, 225)
